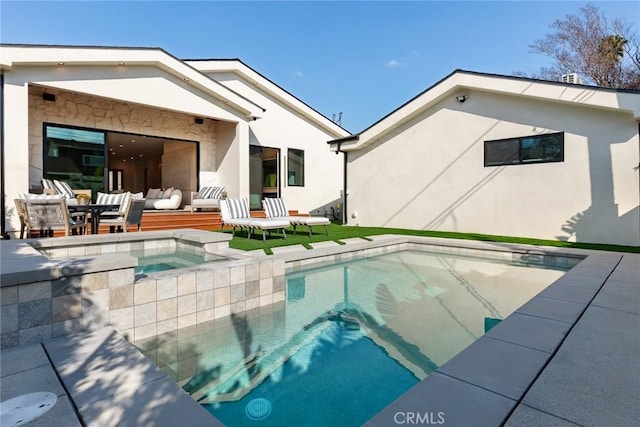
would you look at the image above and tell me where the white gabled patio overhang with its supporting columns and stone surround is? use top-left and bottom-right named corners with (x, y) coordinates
top-left (0, 45), bottom-right (264, 239)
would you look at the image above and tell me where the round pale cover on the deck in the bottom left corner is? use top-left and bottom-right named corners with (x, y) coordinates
top-left (0, 391), bottom-right (58, 427)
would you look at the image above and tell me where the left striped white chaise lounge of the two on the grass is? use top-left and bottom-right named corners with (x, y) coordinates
top-left (220, 198), bottom-right (291, 241)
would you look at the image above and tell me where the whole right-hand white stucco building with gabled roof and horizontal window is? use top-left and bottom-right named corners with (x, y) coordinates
top-left (329, 70), bottom-right (640, 246)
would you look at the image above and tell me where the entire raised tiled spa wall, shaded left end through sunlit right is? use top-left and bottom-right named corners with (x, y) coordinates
top-left (0, 252), bottom-right (285, 348)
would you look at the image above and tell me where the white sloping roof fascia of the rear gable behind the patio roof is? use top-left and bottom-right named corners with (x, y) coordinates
top-left (184, 59), bottom-right (350, 136)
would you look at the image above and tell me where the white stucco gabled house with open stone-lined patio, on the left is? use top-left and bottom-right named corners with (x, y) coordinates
top-left (0, 44), bottom-right (349, 237)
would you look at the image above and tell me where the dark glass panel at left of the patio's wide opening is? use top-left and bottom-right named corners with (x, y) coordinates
top-left (43, 124), bottom-right (106, 193)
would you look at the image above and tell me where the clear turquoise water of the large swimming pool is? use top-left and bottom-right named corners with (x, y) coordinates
top-left (136, 251), bottom-right (568, 426)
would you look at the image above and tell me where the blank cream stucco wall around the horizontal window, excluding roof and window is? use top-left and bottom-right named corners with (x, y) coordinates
top-left (347, 91), bottom-right (640, 245)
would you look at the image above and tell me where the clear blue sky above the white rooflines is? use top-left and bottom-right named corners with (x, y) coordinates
top-left (0, 0), bottom-right (640, 133)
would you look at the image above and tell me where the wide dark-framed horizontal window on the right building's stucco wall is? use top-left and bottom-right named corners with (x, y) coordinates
top-left (484, 132), bottom-right (564, 166)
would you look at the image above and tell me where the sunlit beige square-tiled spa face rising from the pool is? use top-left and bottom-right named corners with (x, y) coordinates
top-left (109, 257), bottom-right (285, 341)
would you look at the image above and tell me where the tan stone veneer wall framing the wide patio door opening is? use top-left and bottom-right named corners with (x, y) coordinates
top-left (29, 90), bottom-right (217, 188)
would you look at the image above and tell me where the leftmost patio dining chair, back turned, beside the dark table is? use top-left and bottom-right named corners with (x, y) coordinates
top-left (21, 199), bottom-right (87, 237)
